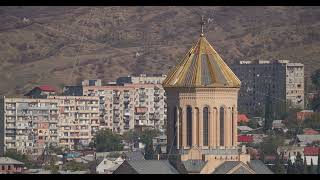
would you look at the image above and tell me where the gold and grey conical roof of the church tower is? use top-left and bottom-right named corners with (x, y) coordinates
top-left (163, 35), bottom-right (240, 87)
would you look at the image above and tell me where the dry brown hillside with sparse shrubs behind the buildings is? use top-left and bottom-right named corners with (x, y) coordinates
top-left (0, 6), bottom-right (320, 96)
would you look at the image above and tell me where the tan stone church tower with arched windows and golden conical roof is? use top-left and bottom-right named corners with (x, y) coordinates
top-left (163, 18), bottom-right (250, 173)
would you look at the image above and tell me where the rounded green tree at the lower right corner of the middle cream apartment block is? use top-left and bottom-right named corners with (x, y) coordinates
top-left (94, 129), bottom-right (123, 152)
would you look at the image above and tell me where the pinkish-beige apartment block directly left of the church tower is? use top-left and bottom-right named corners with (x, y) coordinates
top-left (83, 84), bottom-right (166, 134)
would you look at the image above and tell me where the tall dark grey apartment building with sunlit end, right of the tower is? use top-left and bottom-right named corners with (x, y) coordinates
top-left (230, 60), bottom-right (304, 114)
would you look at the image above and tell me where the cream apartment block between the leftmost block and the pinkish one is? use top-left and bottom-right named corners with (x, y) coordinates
top-left (48, 96), bottom-right (99, 150)
